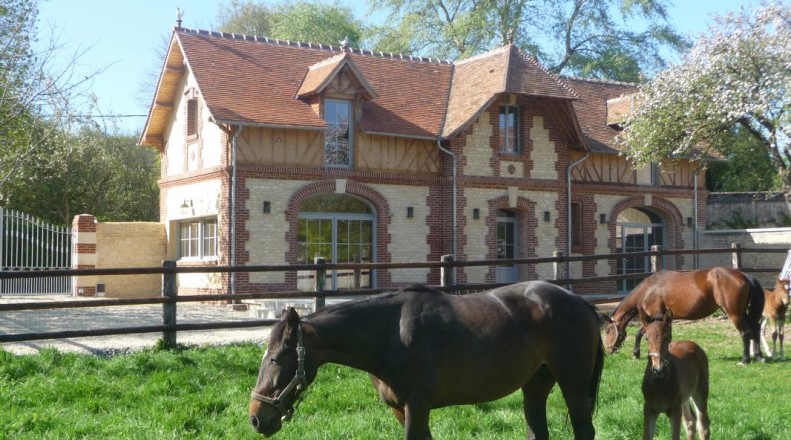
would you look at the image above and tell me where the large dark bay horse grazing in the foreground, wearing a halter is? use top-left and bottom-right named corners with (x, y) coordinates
top-left (249, 281), bottom-right (604, 440)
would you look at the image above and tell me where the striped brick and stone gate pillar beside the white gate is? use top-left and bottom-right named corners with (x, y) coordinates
top-left (71, 214), bottom-right (97, 296)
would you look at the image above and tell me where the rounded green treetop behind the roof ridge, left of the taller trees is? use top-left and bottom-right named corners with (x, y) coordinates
top-left (217, 0), bottom-right (365, 47)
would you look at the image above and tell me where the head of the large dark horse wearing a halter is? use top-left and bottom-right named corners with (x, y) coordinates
top-left (249, 307), bottom-right (316, 437)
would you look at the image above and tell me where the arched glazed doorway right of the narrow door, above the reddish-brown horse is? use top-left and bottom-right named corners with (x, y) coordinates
top-left (615, 207), bottom-right (665, 293)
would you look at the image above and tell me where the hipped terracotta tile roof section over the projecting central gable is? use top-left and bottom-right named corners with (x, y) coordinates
top-left (442, 44), bottom-right (577, 137)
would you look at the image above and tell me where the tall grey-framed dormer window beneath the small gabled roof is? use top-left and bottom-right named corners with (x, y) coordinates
top-left (324, 99), bottom-right (354, 167)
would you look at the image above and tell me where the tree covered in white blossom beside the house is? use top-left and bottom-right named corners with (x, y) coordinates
top-left (621, 1), bottom-right (791, 202)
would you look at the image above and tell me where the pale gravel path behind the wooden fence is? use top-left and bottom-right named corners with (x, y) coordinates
top-left (0, 296), bottom-right (269, 355)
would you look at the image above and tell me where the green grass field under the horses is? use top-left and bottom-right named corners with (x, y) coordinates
top-left (0, 318), bottom-right (791, 440)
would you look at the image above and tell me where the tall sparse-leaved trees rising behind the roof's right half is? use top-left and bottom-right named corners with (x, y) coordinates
top-left (370, 0), bottom-right (687, 81)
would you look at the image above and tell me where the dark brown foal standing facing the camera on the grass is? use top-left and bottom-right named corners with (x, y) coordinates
top-left (640, 309), bottom-right (710, 440)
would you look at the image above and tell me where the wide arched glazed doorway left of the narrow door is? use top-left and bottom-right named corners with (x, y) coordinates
top-left (297, 193), bottom-right (376, 290)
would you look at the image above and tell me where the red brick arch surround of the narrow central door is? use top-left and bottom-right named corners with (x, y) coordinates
top-left (485, 196), bottom-right (538, 283)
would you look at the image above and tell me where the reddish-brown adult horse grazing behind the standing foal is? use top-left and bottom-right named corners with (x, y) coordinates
top-left (604, 267), bottom-right (764, 364)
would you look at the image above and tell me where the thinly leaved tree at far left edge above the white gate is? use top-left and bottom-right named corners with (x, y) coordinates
top-left (0, 0), bottom-right (103, 217)
